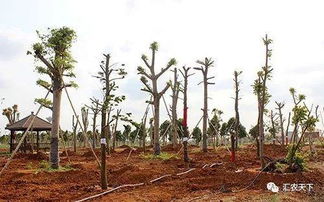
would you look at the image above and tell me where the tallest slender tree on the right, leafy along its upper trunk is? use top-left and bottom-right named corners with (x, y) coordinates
top-left (253, 35), bottom-right (273, 168)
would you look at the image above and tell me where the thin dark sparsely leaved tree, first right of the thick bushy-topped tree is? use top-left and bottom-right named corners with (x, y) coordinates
top-left (95, 54), bottom-right (127, 189)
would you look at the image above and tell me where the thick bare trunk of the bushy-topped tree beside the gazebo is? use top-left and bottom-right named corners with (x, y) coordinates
top-left (50, 80), bottom-right (63, 169)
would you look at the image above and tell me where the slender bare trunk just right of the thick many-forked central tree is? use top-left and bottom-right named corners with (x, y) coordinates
top-left (171, 67), bottom-right (180, 148)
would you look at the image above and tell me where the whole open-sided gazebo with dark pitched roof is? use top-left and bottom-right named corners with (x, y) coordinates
top-left (6, 112), bottom-right (52, 152)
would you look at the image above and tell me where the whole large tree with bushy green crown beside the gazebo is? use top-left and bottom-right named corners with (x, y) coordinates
top-left (27, 27), bottom-right (76, 169)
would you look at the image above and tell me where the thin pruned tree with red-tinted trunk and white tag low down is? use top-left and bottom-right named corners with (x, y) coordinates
top-left (180, 66), bottom-right (193, 163)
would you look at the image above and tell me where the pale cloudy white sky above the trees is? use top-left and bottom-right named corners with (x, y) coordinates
top-left (0, 0), bottom-right (324, 135)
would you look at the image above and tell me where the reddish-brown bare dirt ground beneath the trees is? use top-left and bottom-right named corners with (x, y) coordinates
top-left (0, 145), bottom-right (324, 201)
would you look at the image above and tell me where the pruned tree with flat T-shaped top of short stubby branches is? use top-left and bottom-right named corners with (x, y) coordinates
top-left (194, 57), bottom-right (215, 152)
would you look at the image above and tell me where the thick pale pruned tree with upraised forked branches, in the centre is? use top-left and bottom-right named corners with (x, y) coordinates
top-left (137, 42), bottom-right (176, 155)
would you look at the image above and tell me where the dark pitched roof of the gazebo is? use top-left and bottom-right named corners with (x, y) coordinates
top-left (6, 112), bottom-right (52, 131)
